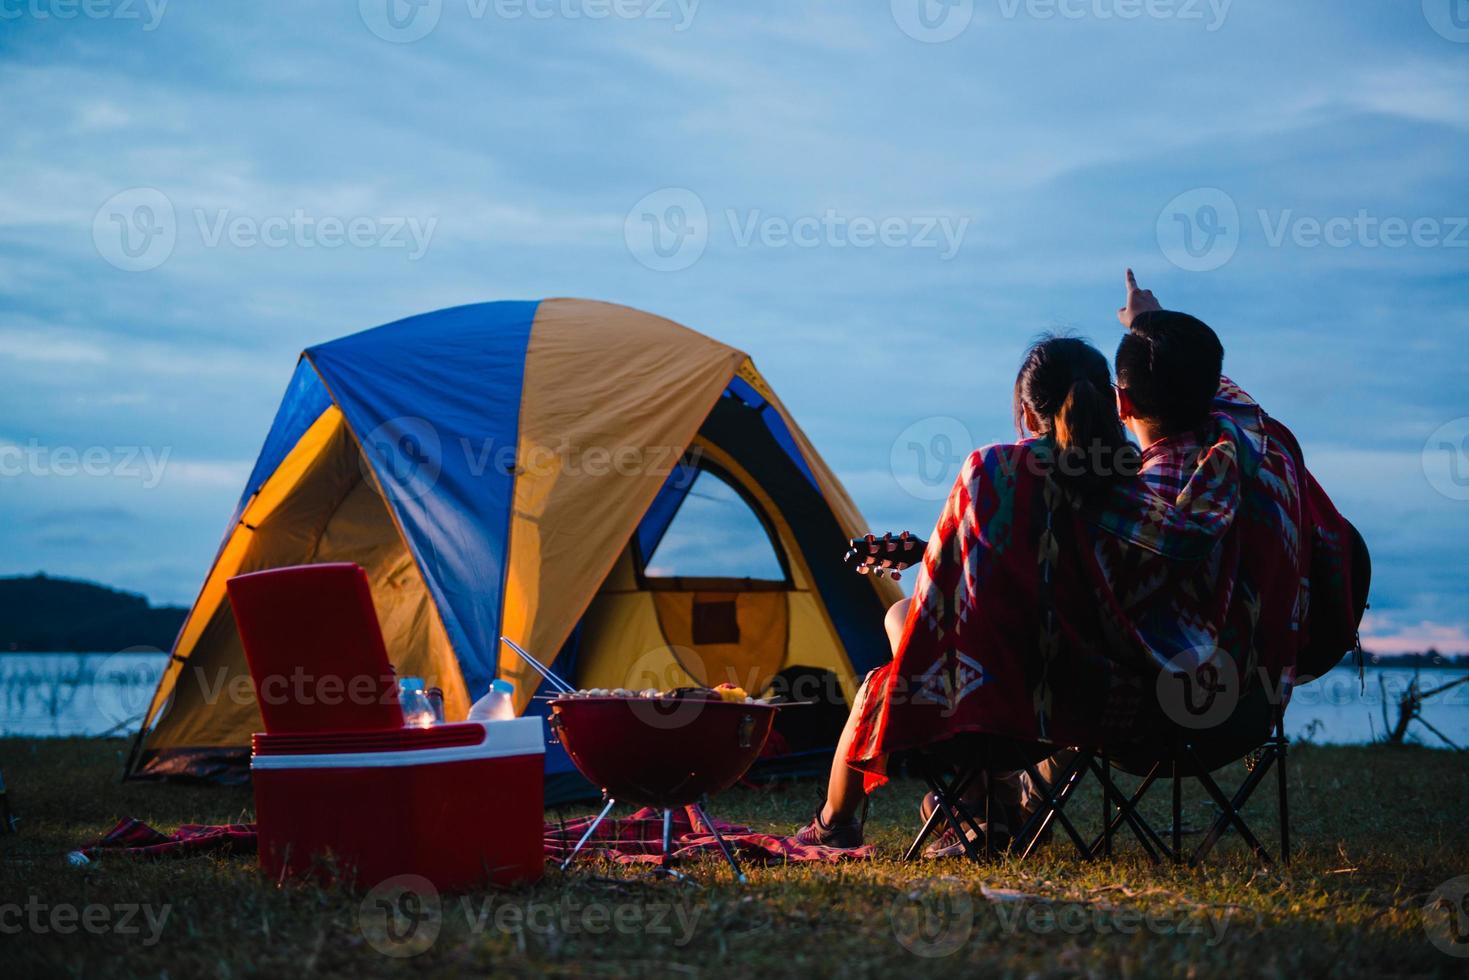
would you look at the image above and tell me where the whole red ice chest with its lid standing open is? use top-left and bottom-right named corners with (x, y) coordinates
top-left (228, 563), bottom-right (545, 890)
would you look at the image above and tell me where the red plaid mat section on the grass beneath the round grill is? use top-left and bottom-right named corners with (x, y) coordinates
top-left (545, 807), bottom-right (873, 864)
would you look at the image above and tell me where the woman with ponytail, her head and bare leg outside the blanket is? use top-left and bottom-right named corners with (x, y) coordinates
top-left (796, 336), bottom-right (1137, 848)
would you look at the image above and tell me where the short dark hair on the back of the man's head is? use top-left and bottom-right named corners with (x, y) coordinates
top-left (1116, 310), bottom-right (1224, 435)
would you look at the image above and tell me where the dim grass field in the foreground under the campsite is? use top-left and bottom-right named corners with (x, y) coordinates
top-left (0, 741), bottom-right (1469, 977)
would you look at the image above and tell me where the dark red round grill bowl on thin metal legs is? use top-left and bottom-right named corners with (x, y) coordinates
top-left (551, 698), bottom-right (777, 808)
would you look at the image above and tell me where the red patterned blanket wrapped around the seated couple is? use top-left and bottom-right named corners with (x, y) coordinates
top-left (848, 379), bottom-right (1341, 785)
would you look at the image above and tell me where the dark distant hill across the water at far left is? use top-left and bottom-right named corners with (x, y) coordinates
top-left (0, 574), bottom-right (188, 652)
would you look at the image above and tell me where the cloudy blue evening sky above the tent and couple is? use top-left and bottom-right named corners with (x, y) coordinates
top-left (0, 0), bottom-right (1469, 620)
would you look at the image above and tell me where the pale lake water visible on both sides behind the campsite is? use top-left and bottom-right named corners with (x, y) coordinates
top-left (0, 652), bottom-right (1469, 748)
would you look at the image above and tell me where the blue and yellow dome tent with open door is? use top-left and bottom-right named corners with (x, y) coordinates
top-left (129, 300), bottom-right (899, 777)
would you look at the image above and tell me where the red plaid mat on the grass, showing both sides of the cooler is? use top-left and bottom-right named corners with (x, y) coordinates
top-left (71, 810), bottom-right (873, 864)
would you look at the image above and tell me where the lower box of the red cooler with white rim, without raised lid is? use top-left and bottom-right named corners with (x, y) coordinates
top-left (250, 718), bottom-right (545, 890)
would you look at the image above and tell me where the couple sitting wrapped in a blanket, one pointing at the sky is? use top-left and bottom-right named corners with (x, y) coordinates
top-left (798, 270), bottom-right (1356, 851)
